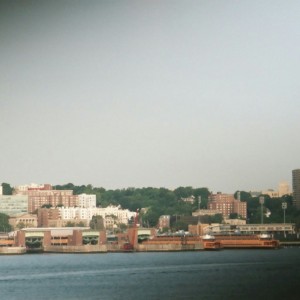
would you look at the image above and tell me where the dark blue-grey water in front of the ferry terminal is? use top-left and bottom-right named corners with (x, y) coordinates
top-left (0, 248), bottom-right (300, 300)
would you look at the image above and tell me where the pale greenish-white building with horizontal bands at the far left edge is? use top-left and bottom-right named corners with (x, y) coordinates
top-left (0, 195), bottom-right (28, 217)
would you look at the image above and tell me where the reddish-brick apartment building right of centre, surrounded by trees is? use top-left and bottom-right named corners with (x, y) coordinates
top-left (208, 193), bottom-right (247, 219)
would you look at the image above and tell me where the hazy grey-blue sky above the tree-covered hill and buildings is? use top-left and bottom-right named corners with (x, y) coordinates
top-left (0, 0), bottom-right (300, 193)
